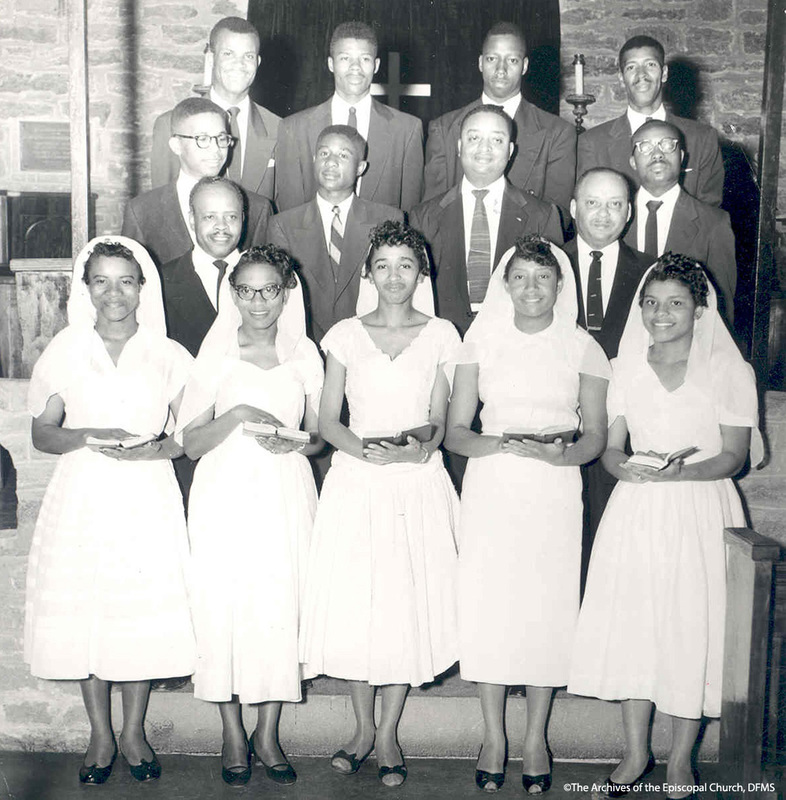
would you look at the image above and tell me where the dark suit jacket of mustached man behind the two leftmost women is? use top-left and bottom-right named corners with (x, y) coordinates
top-left (161, 250), bottom-right (216, 357)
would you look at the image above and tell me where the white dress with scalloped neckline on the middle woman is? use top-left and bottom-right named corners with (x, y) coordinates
top-left (301, 317), bottom-right (459, 686)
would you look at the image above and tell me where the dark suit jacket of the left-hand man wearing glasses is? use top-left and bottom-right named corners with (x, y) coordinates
top-left (122, 181), bottom-right (273, 267)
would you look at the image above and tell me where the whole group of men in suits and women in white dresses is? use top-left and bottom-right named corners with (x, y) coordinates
top-left (25, 12), bottom-right (760, 798)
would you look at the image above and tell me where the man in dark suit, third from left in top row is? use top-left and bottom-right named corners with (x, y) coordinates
top-left (424, 22), bottom-right (576, 218)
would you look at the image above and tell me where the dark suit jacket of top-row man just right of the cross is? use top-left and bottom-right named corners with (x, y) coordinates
top-left (424, 98), bottom-right (576, 220)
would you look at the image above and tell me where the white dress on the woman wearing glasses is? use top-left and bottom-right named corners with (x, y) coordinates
top-left (188, 338), bottom-right (323, 703)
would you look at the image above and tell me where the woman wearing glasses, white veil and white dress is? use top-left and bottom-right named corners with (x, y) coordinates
top-left (178, 245), bottom-right (323, 785)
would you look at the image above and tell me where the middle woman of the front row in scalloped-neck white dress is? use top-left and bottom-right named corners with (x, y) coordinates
top-left (301, 222), bottom-right (459, 786)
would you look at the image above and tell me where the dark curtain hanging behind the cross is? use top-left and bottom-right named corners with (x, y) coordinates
top-left (248, 0), bottom-right (560, 123)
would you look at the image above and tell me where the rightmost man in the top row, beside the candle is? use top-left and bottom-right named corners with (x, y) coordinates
top-left (578, 36), bottom-right (724, 206)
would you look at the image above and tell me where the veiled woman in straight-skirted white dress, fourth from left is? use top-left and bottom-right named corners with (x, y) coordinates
top-left (445, 236), bottom-right (610, 793)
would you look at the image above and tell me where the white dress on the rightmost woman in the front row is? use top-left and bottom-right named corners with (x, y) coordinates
top-left (568, 357), bottom-right (756, 719)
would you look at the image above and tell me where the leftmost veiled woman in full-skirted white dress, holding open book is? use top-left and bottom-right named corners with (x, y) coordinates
top-left (25, 236), bottom-right (195, 784)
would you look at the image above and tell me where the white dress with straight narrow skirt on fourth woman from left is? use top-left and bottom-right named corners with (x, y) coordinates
top-left (458, 323), bottom-right (610, 686)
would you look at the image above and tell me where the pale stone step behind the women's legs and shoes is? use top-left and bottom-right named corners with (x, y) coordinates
top-left (136, 676), bottom-right (720, 761)
